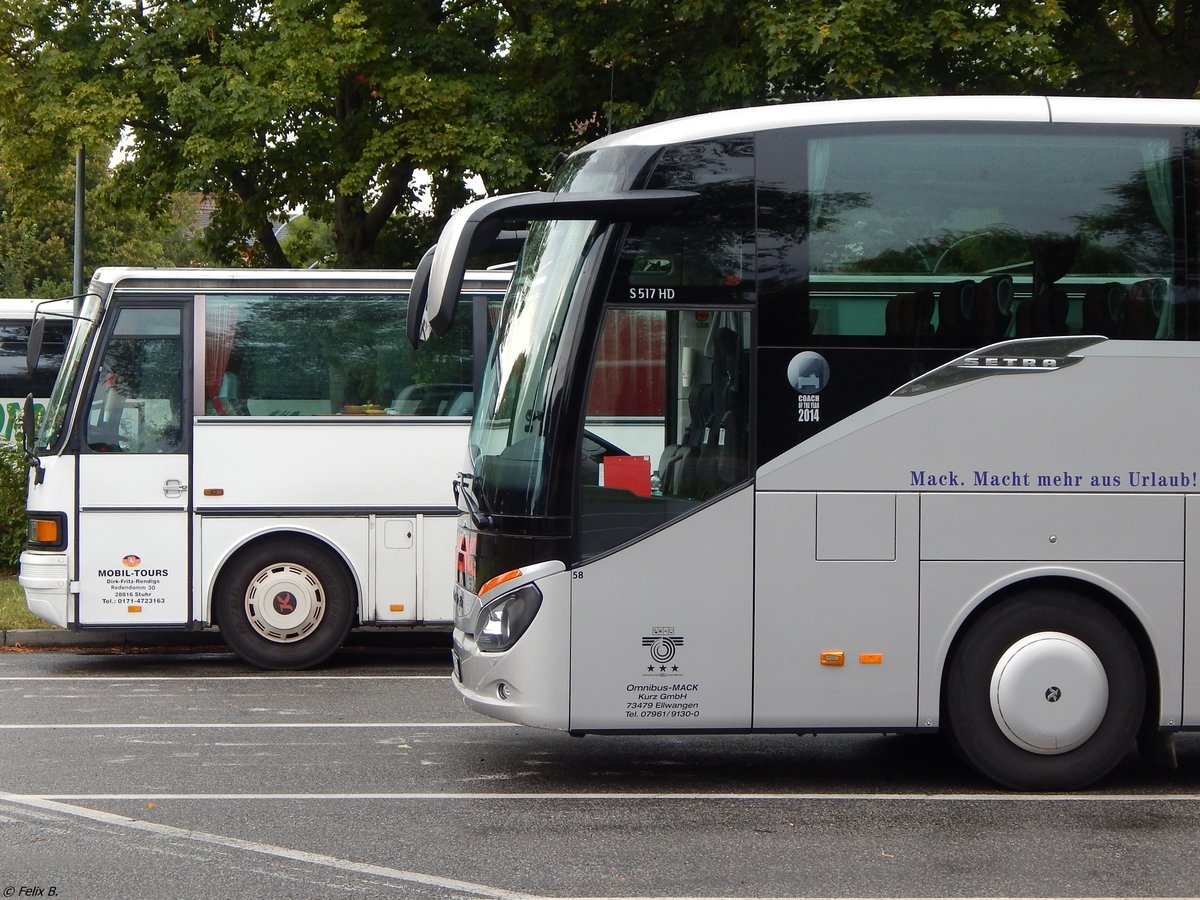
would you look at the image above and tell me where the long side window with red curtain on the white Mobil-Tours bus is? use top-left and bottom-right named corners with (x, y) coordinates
top-left (204, 294), bottom-right (474, 416)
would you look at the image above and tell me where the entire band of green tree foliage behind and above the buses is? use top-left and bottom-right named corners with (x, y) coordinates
top-left (0, 0), bottom-right (1200, 278)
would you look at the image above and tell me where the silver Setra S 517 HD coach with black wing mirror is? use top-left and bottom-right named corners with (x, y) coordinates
top-left (414, 96), bottom-right (1200, 788)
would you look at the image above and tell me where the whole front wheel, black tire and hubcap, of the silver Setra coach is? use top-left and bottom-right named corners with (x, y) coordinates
top-left (942, 589), bottom-right (1146, 791)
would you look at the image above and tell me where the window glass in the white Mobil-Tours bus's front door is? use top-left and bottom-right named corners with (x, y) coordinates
top-left (85, 307), bottom-right (184, 454)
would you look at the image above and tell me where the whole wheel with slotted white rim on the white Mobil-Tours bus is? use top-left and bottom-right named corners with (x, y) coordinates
top-left (212, 539), bottom-right (358, 668)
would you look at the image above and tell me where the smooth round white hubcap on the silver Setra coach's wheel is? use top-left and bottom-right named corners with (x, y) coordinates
top-left (990, 631), bottom-right (1109, 754)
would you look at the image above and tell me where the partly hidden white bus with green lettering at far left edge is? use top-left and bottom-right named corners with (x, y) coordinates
top-left (0, 298), bottom-right (72, 442)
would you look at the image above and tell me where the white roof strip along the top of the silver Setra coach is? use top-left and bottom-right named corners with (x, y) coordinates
top-left (587, 96), bottom-right (1200, 149)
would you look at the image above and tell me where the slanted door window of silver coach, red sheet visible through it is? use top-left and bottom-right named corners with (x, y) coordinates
top-left (580, 307), bottom-right (750, 559)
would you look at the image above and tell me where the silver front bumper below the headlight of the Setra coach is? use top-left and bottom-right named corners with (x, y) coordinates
top-left (454, 572), bottom-right (571, 731)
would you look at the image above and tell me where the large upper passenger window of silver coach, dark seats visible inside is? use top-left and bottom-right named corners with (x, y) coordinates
top-left (760, 126), bottom-right (1183, 340)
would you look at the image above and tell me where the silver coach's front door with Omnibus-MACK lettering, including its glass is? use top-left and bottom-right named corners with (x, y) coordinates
top-left (570, 306), bottom-right (754, 730)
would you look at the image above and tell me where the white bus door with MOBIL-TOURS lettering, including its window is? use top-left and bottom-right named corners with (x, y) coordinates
top-left (76, 301), bottom-right (191, 626)
